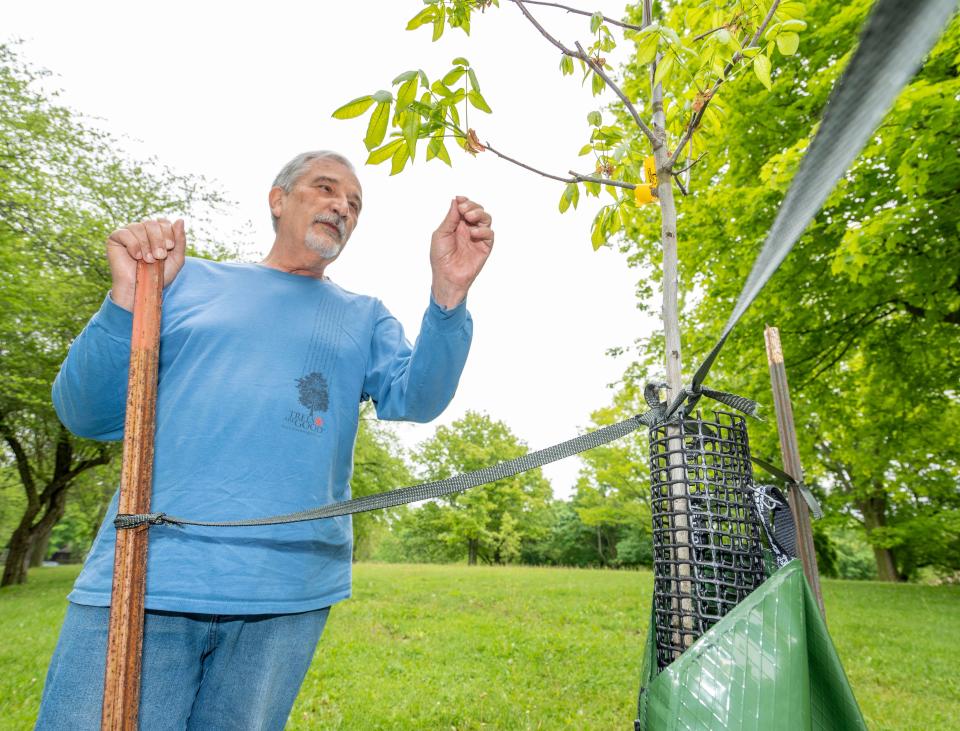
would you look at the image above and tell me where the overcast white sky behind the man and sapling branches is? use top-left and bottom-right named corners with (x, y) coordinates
top-left (7, 0), bottom-right (659, 496)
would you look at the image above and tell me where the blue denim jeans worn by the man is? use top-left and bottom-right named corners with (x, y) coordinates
top-left (36, 603), bottom-right (330, 731)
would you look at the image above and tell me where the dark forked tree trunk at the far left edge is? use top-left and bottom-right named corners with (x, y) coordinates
top-left (0, 424), bottom-right (111, 586)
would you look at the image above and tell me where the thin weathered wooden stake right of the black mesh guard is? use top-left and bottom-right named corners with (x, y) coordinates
top-left (763, 326), bottom-right (827, 619)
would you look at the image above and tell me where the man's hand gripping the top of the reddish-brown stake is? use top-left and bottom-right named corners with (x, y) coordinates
top-left (107, 218), bottom-right (187, 311)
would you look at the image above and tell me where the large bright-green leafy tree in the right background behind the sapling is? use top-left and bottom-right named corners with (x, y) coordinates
top-left (625, 0), bottom-right (960, 580)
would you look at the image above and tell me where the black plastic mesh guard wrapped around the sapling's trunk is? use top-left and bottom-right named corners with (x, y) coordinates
top-left (650, 411), bottom-right (764, 669)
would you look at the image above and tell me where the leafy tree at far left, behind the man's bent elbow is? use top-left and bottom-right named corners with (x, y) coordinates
top-left (0, 46), bottom-right (226, 586)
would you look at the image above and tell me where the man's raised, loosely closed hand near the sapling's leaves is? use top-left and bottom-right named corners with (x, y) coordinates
top-left (430, 195), bottom-right (493, 309)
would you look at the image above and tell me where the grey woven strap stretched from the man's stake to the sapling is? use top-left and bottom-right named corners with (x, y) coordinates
top-left (113, 416), bottom-right (644, 528)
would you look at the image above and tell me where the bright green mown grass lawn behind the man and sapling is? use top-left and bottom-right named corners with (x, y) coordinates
top-left (0, 564), bottom-right (960, 731)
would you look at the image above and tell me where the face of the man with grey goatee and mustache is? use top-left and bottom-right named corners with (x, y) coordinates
top-left (271, 158), bottom-right (362, 260)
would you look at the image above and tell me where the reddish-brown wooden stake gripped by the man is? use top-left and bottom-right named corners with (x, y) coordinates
top-left (100, 260), bottom-right (163, 731)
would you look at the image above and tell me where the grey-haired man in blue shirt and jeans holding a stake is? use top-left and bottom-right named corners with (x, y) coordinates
top-left (37, 151), bottom-right (493, 731)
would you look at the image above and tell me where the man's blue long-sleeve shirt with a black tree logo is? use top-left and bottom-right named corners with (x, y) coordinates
top-left (53, 258), bottom-right (472, 614)
